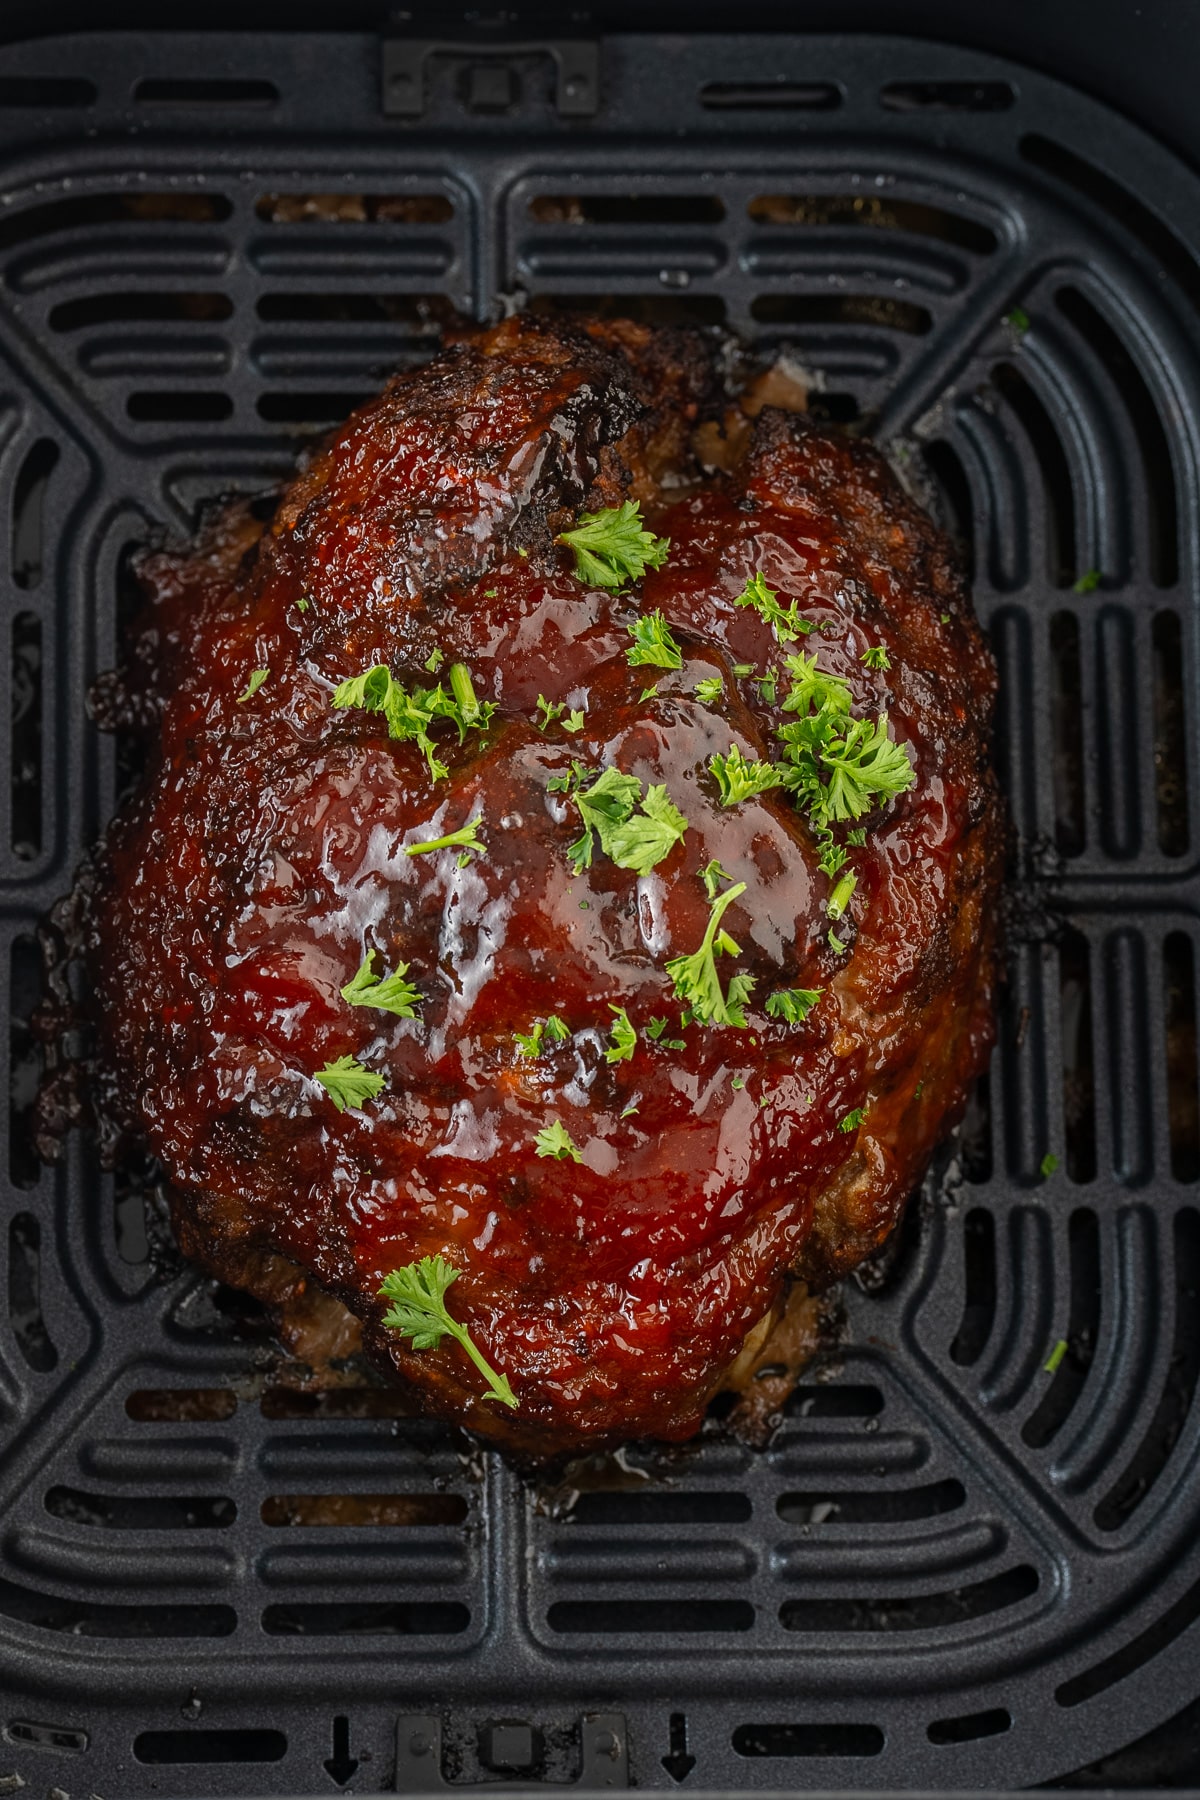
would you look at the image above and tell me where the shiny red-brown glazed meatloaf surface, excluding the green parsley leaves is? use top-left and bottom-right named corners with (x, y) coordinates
top-left (49, 322), bottom-right (1000, 1454)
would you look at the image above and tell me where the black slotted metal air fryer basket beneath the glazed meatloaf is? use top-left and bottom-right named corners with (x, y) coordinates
top-left (0, 17), bottom-right (1200, 1796)
